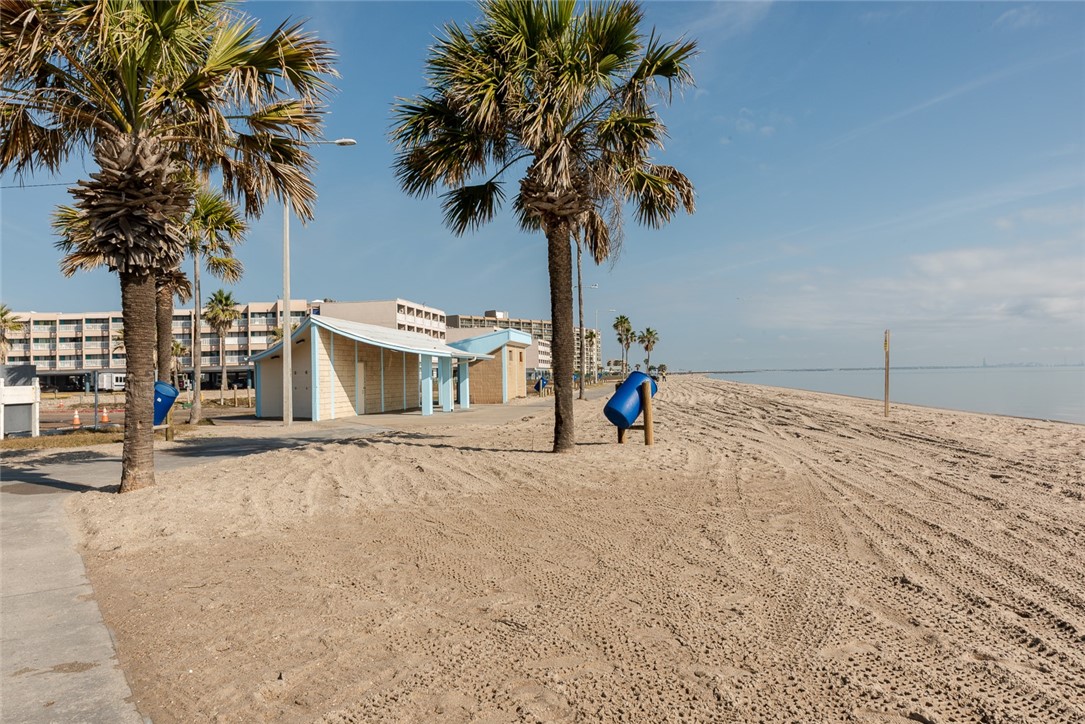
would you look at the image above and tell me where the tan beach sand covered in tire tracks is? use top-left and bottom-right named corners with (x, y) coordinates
top-left (71, 376), bottom-right (1085, 724)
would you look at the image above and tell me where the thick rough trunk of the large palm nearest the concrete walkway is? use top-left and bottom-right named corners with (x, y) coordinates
top-left (120, 272), bottom-right (156, 493)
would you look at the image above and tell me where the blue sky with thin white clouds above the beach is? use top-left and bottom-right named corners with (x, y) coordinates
top-left (0, 2), bottom-right (1085, 369)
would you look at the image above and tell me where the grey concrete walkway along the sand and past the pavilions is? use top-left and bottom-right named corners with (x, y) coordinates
top-left (0, 385), bottom-right (613, 724)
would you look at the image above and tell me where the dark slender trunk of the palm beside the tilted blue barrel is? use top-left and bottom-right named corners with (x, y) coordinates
top-left (546, 219), bottom-right (576, 453)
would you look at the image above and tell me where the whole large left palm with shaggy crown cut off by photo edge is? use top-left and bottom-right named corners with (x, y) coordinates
top-left (0, 0), bottom-right (333, 492)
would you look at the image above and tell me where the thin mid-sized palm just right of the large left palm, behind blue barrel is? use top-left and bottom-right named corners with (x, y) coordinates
top-left (186, 186), bottom-right (248, 424)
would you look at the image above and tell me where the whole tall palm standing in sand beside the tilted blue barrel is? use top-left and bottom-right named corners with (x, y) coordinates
top-left (392, 0), bottom-right (695, 453)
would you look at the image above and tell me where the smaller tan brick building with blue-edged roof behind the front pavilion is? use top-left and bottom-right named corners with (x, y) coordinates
top-left (448, 329), bottom-right (532, 405)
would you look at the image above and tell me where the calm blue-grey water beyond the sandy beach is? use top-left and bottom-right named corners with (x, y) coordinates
top-left (709, 367), bottom-right (1085, 424)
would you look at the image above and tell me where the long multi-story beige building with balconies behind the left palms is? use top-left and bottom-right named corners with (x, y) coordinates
top-left (8, 300), bottom-right (309, 388)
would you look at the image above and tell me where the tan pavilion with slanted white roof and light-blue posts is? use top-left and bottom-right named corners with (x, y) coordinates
top-left (252, 315), bottom-right (488, 420)
